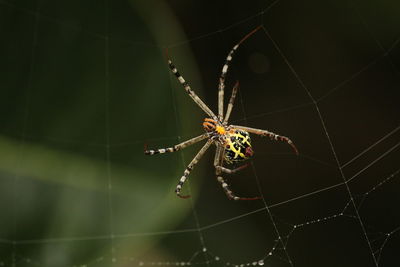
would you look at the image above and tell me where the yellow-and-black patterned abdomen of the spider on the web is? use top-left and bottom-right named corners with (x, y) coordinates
top-left (224, 130), bottom-right (253, 163)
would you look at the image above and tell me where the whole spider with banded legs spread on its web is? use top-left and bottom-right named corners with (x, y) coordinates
top-left (144, 26), bottom-right (298, 200)
